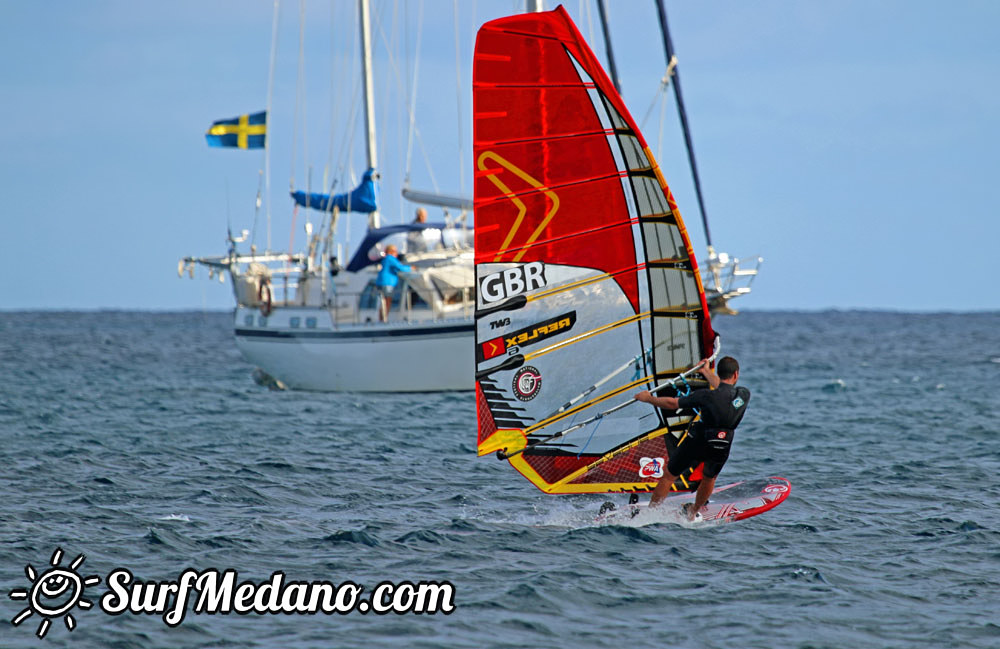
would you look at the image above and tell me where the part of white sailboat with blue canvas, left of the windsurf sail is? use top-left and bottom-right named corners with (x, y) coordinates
top-left (178, 0), bottom-right (474, 392)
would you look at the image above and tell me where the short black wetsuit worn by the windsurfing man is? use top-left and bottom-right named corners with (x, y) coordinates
top-left (667, 383), bottom-right (750, 478)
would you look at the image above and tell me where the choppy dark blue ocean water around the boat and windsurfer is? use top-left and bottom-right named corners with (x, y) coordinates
top-left (0, 311), bottom-right (1000, 649)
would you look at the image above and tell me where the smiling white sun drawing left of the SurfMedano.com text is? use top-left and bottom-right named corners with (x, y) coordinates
top-left (10, 548), bottom-right (101, 638)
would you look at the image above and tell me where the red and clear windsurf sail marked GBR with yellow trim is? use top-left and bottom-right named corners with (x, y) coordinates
top-left (473, 7), bottom-right (717, 493)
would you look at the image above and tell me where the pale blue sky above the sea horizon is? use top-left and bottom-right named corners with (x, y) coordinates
top-left (0, 0), bottom-right (1000, 311)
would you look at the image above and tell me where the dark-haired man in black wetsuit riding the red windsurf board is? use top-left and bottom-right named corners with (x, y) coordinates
top-left (635, 356), bottom-right (750, 520)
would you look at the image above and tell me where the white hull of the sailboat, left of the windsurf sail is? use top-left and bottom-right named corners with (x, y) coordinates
top-left (235, 308), bottom-right (475, 392)
